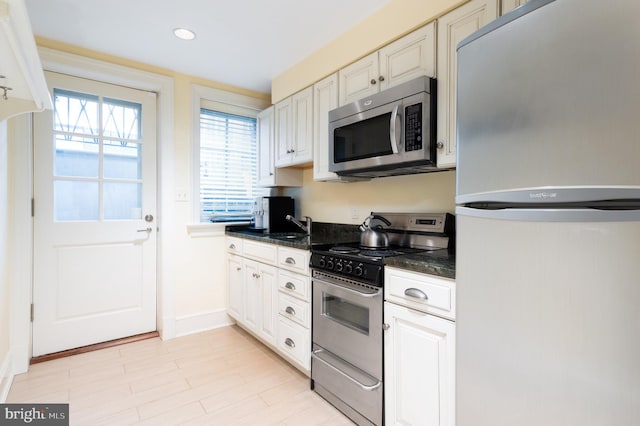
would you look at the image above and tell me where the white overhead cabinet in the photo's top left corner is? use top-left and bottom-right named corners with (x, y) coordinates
top-left (0, 0), bottom-right (52, 121)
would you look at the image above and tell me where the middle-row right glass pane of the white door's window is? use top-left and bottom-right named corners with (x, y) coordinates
top-left (104, 141), bottom-right (142, 179)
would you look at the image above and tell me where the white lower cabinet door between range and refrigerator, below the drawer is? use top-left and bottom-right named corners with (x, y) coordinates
top-left (384, 302), bottom-right (455, 426)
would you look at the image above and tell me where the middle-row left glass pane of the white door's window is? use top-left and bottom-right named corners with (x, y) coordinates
top-left (53, 134), bottom-right (100, 178)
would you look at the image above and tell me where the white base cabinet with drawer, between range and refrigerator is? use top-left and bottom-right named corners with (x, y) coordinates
top-left (384, 267), bottom-right (456, 426)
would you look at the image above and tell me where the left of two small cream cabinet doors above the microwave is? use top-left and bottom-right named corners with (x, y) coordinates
top-left (338, 52), bottom-right (380, 105)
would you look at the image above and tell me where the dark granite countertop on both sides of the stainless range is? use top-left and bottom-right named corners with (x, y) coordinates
top-left (226, 222), bottom-right (456, 279)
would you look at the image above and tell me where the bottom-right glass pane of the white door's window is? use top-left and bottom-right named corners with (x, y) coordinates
top-left (104, 182), bottom-right (142, 220)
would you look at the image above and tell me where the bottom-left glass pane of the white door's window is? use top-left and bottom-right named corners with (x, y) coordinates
top-left (53, 180), bottom-right (100, 221)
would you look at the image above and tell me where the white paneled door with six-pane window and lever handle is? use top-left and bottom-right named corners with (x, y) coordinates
top-left (33, 73), bottom-right (157, 356)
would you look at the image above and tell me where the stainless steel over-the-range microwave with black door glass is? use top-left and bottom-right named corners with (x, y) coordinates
top-left (329, 76), bottom-right (437, 178)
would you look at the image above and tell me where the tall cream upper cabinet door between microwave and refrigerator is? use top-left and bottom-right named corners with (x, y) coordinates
top-left (437, 0), bottom-right (498, 167)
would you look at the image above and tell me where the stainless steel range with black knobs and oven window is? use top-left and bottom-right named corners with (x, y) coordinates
top-left (311, 213), bottom-right (455, 425)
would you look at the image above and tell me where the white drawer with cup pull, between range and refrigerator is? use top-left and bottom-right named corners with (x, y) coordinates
top-left (384, 267), bottom-right (455, 319)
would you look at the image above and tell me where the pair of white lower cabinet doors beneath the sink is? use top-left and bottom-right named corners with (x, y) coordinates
top-left (243, 259), bottom-right (278, 344)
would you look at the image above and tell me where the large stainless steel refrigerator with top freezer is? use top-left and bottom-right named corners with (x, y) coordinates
top-left (456, 0), bottom-right (640, 426)
